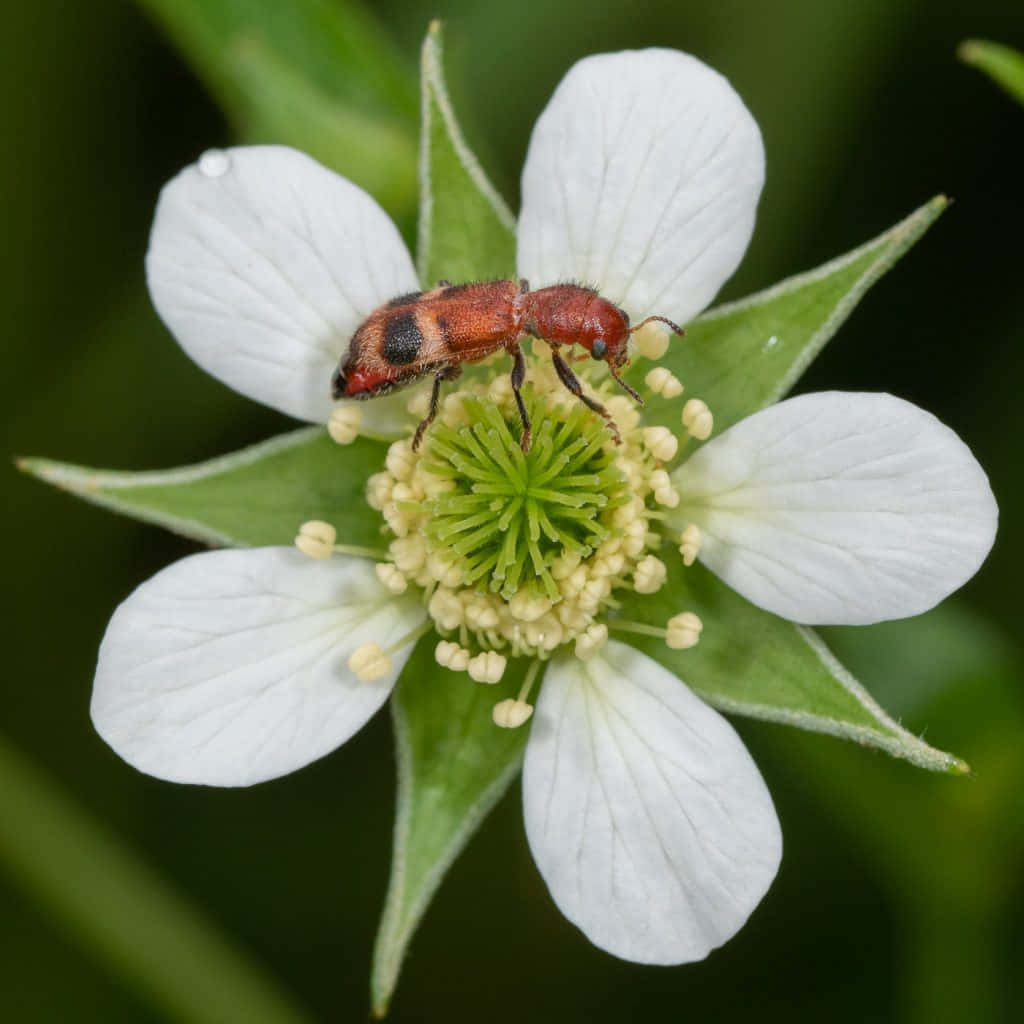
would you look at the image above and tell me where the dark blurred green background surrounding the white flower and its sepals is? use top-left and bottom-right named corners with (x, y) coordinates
top-left (0, 0), bottom-right (1024, 1022)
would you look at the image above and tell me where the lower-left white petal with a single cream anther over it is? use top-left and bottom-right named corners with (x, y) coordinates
top-left (92, 548), bottom-right (423, 785)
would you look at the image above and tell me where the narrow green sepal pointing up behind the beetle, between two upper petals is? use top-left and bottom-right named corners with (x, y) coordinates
top-left (417, 22), bottom-right (515, 288)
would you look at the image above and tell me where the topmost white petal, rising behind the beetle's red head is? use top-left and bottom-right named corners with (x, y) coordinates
top-left (518, 49), bottom-right (764, 323)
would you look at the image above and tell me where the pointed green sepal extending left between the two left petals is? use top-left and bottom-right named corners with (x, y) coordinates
top-left (18, 427), bottom-right (387, 548)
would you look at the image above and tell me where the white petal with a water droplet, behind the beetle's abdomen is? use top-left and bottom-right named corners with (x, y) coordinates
top-left (146, 145), bottom-right (419, 423)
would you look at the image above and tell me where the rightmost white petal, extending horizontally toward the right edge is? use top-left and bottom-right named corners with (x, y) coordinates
top-left (673, 391), bottom-right (997, 625)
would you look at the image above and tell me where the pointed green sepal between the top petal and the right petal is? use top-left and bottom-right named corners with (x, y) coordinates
top-left (644, 196), bottom-right (947, 433)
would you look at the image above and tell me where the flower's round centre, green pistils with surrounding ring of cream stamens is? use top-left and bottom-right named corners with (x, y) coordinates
top-left (368, 359), bottom-right (678, 659)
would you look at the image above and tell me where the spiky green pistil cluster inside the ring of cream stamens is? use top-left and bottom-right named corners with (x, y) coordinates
top-left (423, 394), bottom-right (628, 601)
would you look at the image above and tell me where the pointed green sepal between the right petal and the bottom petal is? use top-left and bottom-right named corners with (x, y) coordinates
top-left (612, 558), bottom-right (968, 774)
